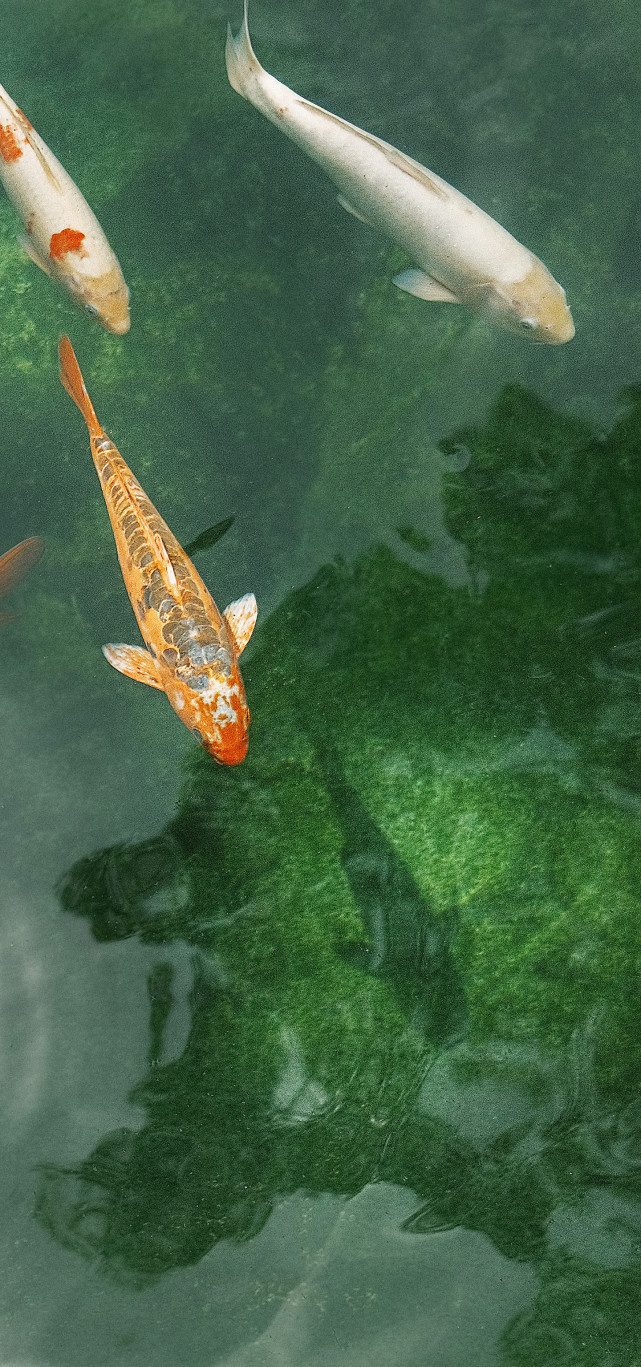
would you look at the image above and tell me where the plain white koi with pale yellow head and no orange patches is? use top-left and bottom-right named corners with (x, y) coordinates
top-left (226, 0), bottom-right (574, 343)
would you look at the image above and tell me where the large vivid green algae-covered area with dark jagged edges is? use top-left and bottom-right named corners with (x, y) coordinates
top-left (38, 390), bottom-right (641, 1306)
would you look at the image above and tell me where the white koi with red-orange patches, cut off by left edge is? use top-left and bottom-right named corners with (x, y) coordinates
top-left (0, 86), bottom-right (130, 334)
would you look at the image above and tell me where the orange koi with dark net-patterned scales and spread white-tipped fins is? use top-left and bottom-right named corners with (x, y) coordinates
top-left (60, 336), bottom-right (257, 764)
